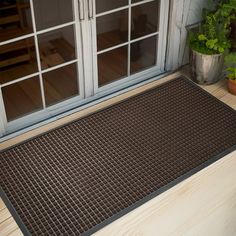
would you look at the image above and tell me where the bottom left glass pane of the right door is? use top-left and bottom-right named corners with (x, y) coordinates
top-left (98, 46), bottom-right (128, 86)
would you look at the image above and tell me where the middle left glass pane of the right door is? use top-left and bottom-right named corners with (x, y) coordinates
top-left (97, 10), bottom-right (128, 51)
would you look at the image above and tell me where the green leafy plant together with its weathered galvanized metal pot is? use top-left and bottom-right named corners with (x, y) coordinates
top-left (189, 3), bottom-right (231, 84)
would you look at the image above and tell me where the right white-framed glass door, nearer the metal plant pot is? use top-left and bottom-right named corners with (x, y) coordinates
top-left (93, 0), bottom-right (168, 93)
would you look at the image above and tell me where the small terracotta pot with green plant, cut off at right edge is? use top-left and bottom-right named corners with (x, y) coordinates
top-left (225, 53), bottom-right (236, 95)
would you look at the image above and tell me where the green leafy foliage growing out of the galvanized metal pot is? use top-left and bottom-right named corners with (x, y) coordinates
top-left (188, 0), bottom-right (232, 55)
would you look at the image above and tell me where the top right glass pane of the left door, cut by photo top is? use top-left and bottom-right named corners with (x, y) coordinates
top-left (33, 0), bottom-right (73, 31)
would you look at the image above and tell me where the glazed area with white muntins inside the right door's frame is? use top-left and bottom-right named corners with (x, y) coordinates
top-left (95, 0), bottom-right (161, 88)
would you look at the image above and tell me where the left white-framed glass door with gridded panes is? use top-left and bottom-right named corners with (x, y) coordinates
top-left (0, 0), bottom-right (84, 136)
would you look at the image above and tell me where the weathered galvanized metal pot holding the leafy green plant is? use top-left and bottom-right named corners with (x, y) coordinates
top-left (190, 49), bottom-right (224, 84)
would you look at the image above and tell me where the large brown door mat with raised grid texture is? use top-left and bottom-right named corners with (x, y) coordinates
top-left (0, 78), bottom-right (236, 235)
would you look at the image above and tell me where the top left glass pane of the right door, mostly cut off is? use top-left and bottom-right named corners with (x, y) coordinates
top-left (96, 0), bottom-right (128, 14)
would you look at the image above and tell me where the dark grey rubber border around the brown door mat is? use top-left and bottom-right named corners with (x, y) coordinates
top-left (0, 75), bottom-right (236, 236)
